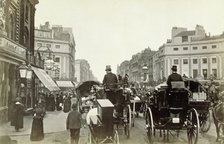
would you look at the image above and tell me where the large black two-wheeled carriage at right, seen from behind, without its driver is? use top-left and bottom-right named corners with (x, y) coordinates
top-left (146, 82), bottom-right (200, 144)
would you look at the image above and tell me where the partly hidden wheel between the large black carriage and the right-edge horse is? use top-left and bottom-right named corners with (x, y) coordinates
top-left (199, 111), bottom-right (211, 133)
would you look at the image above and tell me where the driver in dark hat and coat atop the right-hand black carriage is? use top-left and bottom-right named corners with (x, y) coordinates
top-left (167, 65), bottom-right (183, 88)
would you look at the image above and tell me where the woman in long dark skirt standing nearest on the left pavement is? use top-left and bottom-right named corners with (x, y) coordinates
top-left (30, 103), bottom-right (44, 141)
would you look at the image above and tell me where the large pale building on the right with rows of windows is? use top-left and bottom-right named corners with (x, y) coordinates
top-left (153, 25), bottom-right (224, 81)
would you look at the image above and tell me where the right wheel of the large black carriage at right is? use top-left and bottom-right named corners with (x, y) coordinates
top-left (187, 108), bottom-right (200, 144)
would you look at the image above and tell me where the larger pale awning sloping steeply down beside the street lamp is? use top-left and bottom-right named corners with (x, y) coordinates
top-left (32, 66), bottom-right (60, 91)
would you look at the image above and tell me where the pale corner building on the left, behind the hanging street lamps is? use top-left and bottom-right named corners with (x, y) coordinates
top-left (35, 22), bottom-right (76, 81)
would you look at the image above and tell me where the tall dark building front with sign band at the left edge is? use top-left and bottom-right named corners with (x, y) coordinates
top-left (0, 0), bottom-right (41, 123)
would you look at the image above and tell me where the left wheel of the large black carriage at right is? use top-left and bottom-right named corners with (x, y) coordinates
top-left (145, 108), bottom-right (154, 144)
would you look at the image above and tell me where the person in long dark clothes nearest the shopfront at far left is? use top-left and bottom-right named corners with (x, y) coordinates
top-left (11, 101), bottom-right (25, 131)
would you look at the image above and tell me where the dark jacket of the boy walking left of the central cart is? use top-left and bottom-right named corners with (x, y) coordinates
top-left (66, 110), bottom-right (82, 129)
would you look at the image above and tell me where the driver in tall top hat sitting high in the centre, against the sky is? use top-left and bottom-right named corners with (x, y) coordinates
top-left (103, 65), bottom-right (118, 104)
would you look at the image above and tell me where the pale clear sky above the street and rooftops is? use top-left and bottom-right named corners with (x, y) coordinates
top-left (35, 0), bottom-right (224, 81)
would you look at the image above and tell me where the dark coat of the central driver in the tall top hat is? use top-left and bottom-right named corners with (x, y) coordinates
top-left (103, 73), bottom-right (118, 90)
